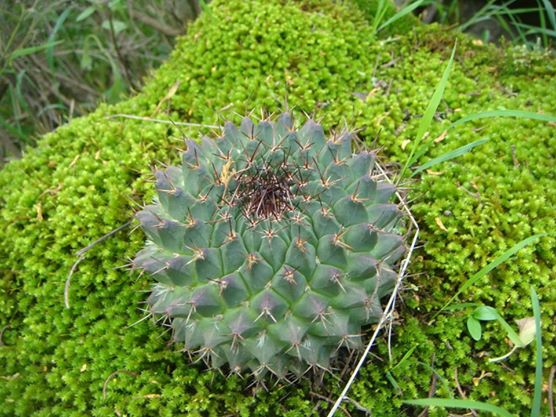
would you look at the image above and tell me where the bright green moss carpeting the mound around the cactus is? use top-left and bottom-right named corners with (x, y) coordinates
top-left (0, 0), bottom-right (556, 416)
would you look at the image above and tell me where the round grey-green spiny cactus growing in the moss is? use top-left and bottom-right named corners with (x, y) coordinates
top-left (134, 113), bottom-right (404, 379)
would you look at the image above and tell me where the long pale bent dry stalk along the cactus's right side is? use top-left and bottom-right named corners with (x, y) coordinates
top-left (327, 164), bottom-right (419, 417)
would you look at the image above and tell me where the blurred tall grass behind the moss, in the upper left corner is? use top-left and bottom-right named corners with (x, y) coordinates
top-left (0, 0), bottom-right (201, 166)
